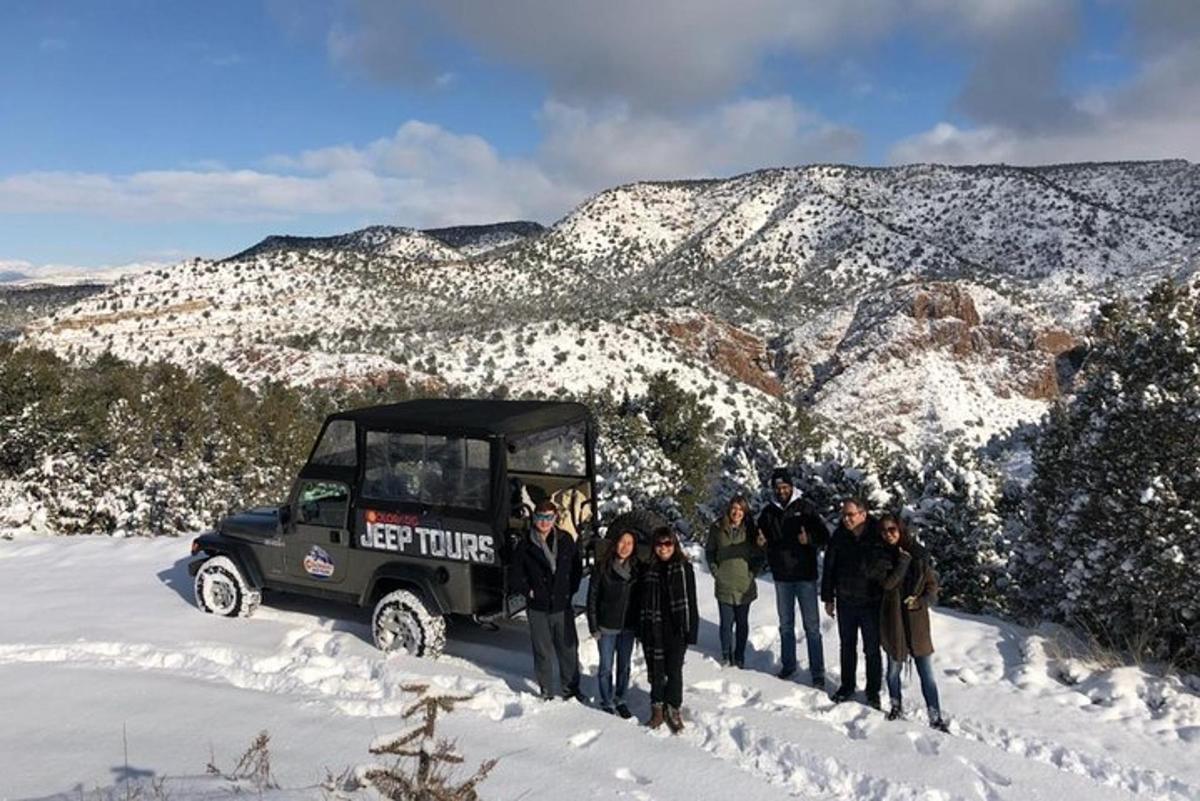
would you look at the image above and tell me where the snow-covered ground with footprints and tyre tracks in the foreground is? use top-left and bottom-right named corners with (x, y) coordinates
top-left (0, 537), bottom-right (1200, 801)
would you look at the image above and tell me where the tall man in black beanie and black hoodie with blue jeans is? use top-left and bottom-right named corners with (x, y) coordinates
top-left (758, 468), bottom-right (829, 687)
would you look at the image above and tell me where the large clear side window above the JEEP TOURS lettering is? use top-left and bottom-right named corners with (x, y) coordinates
top-left (362, 430), bottom-right (491, 510)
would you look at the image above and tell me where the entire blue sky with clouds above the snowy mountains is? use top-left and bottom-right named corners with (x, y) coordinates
top-left (0, 0), bottom-right (1200, 272)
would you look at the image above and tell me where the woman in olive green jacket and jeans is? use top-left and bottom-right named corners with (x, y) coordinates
top-left (704, 495), bottom-right (762, 668)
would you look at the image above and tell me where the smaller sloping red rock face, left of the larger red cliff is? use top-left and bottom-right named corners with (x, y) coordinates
top-left (662, 314), bottom-right (784, 398)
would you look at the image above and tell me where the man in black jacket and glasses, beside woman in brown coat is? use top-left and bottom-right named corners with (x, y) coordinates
top-left (821, 498), bottom-right (883, 709)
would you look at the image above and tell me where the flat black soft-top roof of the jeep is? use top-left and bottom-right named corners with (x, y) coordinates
top-left (329, 399), bottom-right (592, 436)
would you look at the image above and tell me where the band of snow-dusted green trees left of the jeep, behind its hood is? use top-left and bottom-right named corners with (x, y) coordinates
top-left (0, 347), bottom-right (422, 535)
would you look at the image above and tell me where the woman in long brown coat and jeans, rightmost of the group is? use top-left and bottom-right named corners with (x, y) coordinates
top-left (878, 514), bottom-right (948, 731)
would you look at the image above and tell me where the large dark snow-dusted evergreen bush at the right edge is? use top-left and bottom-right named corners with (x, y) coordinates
top-left (1014, 283), bottom-right (1200, 668)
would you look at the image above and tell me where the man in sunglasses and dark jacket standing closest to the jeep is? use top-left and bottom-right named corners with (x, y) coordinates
top-left (511, 501), bottom-right (584, 701)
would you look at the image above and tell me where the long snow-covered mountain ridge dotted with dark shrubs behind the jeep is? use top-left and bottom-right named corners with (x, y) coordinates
top-left (16, 162), bottom-right (1200, 445)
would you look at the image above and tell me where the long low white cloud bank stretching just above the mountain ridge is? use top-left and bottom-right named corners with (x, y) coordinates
top-left (0, 97), bottom-right (859, 227)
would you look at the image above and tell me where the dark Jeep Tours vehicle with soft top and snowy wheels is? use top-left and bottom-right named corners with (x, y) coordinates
top-left (188, 399), bottom-right (619, 656)
